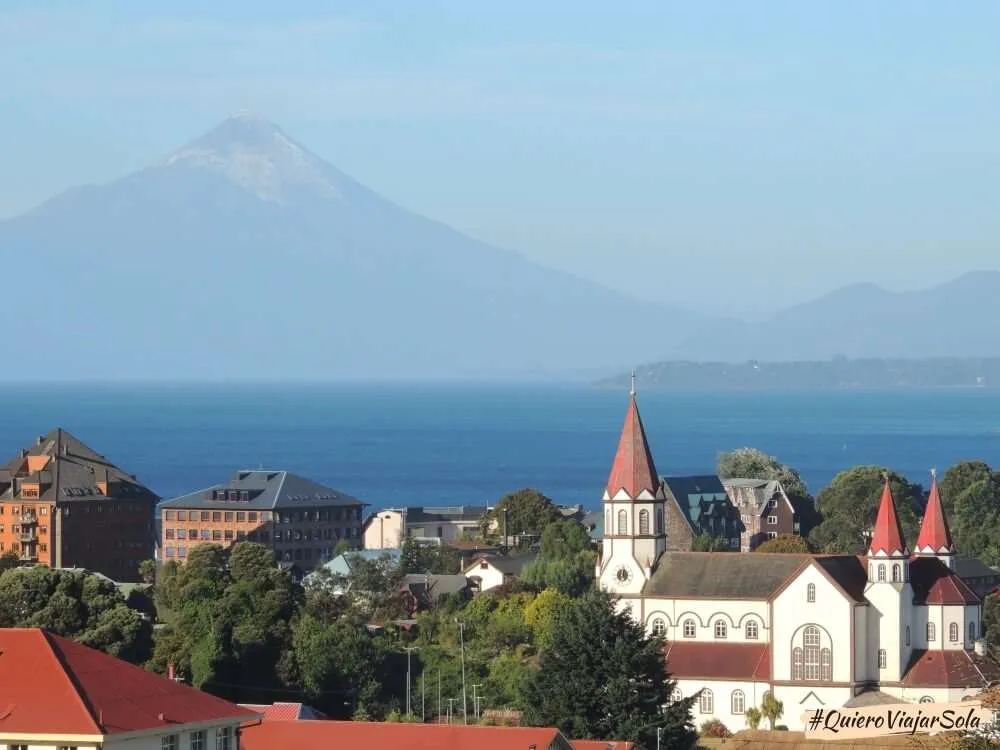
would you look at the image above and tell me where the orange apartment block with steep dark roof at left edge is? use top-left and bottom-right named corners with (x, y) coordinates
top-left (0, 429), bottom-right (159, 582)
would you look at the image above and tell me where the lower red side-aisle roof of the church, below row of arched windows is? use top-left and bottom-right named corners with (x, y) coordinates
top-left (664, 641), bottom-right (771, 680)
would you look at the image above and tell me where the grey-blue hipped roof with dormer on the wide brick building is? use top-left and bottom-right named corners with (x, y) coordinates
top-left (160, 469), bottom-right (364, 510)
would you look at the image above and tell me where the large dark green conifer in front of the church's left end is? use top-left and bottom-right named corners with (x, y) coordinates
top-left (524, 589), bottom-right (697, 750)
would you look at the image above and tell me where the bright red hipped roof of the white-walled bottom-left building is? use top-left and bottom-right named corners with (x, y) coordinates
top-left (0, 628), bottom-right (257, 736)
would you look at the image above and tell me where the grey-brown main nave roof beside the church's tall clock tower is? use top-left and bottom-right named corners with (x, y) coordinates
top-left (642, 552), bottom-right (812, 599)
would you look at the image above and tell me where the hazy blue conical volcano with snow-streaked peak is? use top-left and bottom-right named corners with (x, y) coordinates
top-left (0, 117), bottom-right (704, 379)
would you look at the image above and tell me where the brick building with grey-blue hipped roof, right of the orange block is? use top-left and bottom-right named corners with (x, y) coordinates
top-left (159, 469), bottom-right (364, 571)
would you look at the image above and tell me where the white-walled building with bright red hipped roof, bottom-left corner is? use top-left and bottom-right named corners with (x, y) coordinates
top-left (0, 628), bottom-right (259, 750)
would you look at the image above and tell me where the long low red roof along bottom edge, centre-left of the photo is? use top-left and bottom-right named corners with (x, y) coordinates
top-left (240, 721), bottom-right (572, 750)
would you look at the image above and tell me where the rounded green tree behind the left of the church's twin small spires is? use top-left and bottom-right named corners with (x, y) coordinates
top-left (809, 466), bottom-right (923, 555)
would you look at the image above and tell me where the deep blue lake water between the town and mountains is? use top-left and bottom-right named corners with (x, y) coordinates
top-left (0, 385), bottom-right (1000, 508)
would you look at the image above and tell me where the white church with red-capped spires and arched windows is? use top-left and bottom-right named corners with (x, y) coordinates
top-left (596, 392), bottom-right (1000, 732)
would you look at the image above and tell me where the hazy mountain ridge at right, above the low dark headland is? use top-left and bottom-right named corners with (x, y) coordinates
top-left (661, 271), bottom-right (1000, 362)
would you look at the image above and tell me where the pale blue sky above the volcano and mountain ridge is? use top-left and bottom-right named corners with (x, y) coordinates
top-left (0, 0), bottom-right (1000, 312)
